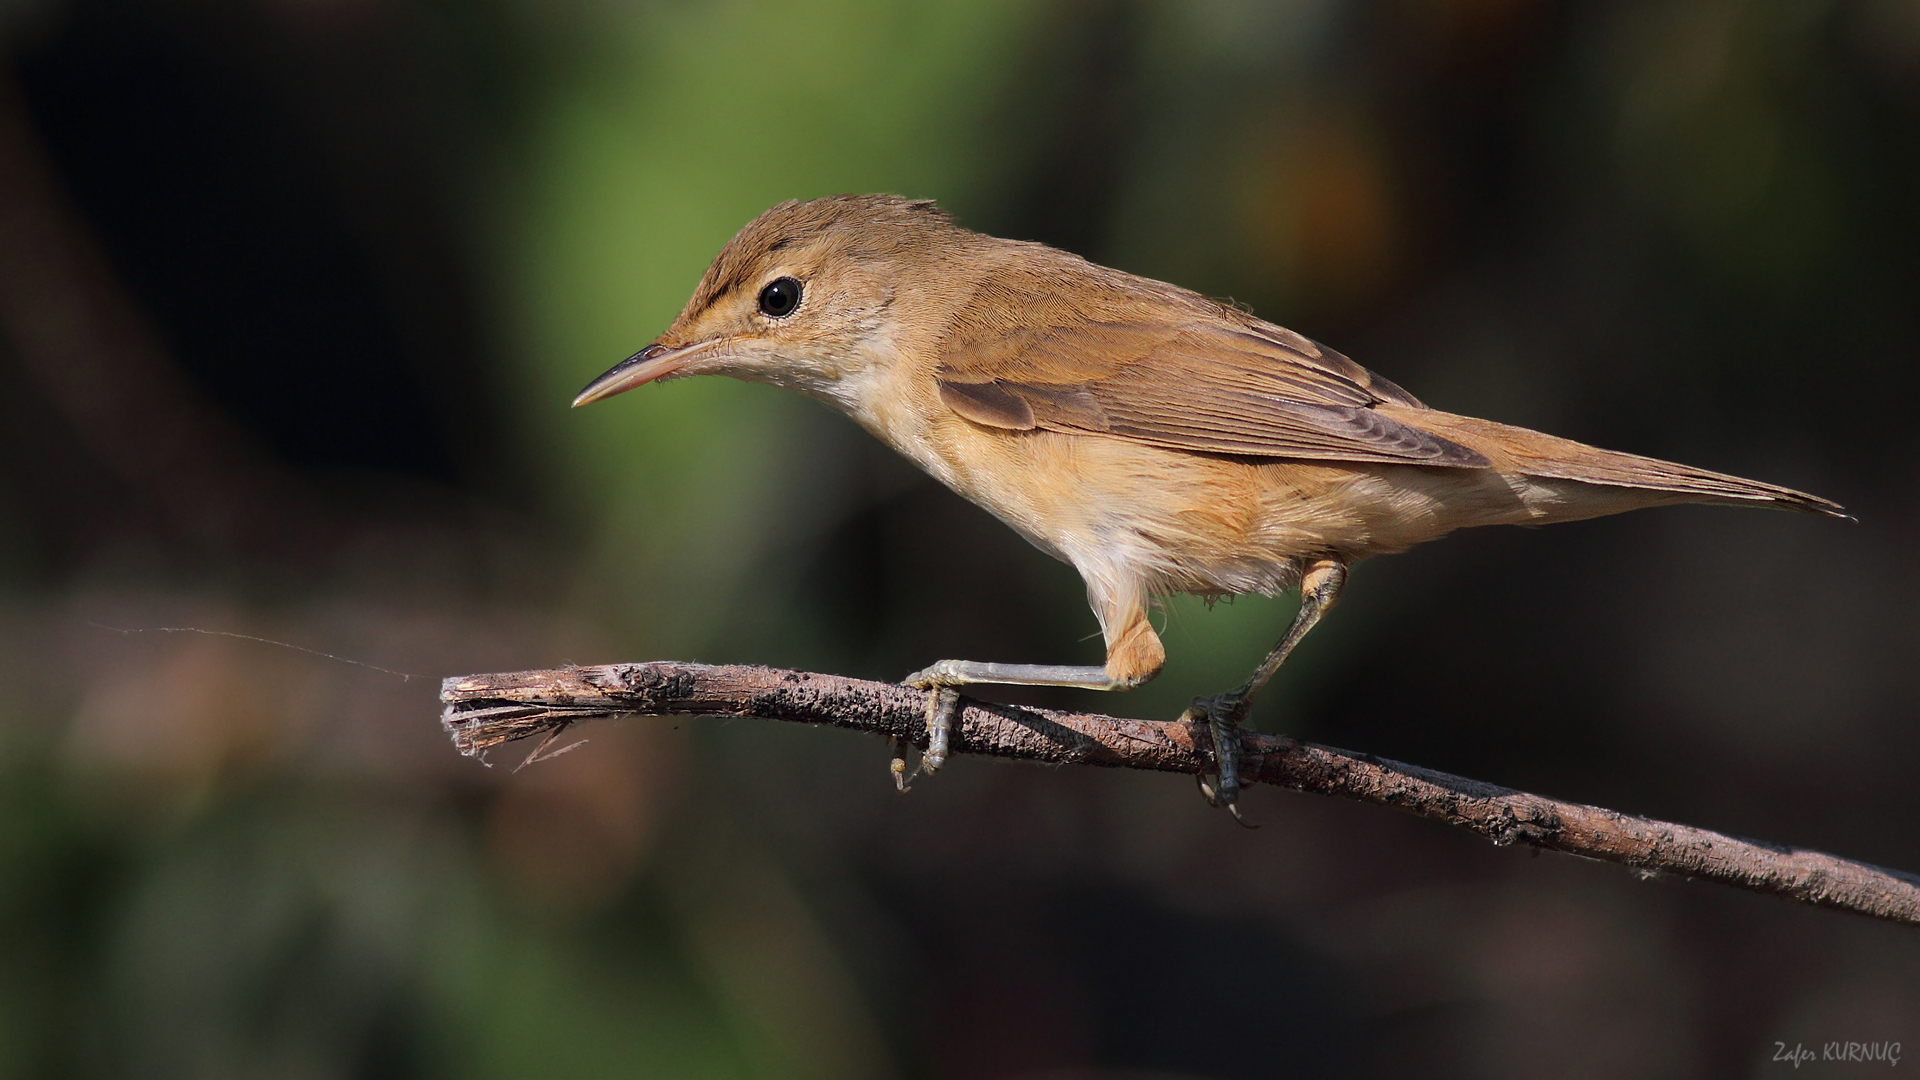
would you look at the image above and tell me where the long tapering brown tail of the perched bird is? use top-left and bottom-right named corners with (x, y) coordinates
top-left (1396, 411), bottom-right (1853, 521)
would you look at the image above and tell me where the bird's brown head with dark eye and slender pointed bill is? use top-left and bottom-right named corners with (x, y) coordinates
top-left (574, 196), bottom-right (968, 407)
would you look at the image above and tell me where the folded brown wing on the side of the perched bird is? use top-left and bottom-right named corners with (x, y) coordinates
top-left (937, 309), bottom-right (1488, 469)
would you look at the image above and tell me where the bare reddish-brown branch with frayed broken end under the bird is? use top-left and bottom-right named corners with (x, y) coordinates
top-left (440, 663), bottom-right (1920, 926)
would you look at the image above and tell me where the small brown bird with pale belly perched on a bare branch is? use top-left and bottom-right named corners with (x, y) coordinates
top-left (574, 196), bottom-right (1845, 807)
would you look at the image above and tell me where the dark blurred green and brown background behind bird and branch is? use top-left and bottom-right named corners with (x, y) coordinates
top-left (0, 0), bottom-right (1920, 1080)
